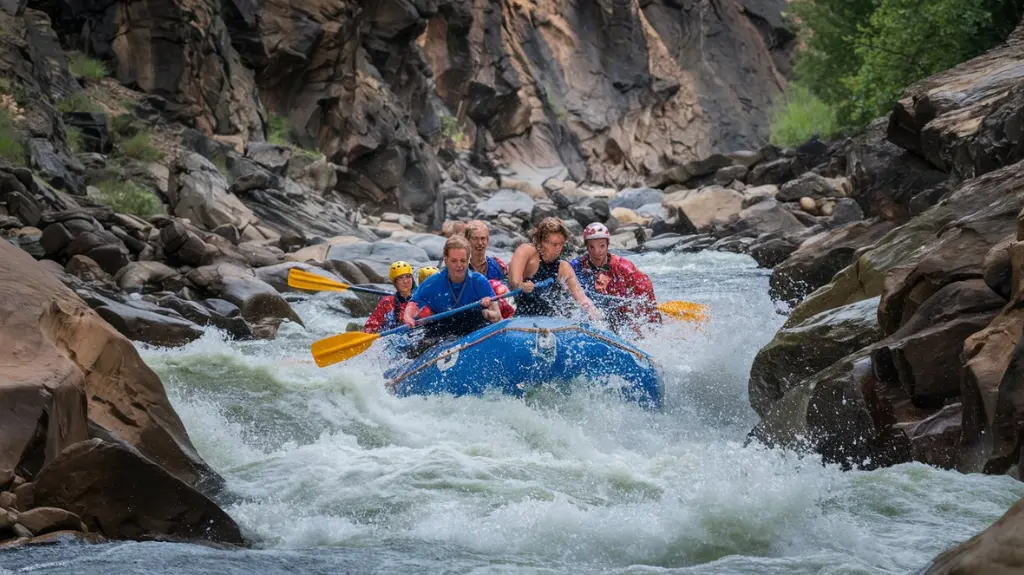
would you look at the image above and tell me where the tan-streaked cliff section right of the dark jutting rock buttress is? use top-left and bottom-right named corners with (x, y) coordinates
top-left (423, 0), bottom-right (788, 185)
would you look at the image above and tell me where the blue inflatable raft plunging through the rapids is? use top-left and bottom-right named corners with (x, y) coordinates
top-left (384, 317), bottom-right (664, 409)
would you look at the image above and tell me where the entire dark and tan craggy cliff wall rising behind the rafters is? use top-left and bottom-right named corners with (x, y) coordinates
top-left (29, 0), bottom-right (793, 221)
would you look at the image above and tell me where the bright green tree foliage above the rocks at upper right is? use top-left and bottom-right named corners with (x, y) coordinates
top-left (772, 0), bottom-right (1024, 145)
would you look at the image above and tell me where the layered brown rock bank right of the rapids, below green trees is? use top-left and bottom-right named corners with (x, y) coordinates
top-left (750, 21), bottom-right (1024, 476)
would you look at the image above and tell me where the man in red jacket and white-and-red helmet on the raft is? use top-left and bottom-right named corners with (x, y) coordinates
top-left (570, 222), bottom-right (662, 333)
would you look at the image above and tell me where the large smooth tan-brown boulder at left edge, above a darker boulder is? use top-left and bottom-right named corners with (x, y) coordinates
top-left (0, 241), bottom-right (228, 499)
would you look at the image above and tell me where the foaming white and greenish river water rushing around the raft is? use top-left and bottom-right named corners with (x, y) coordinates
top-left (0, 253), bottom-right (1024, 575)
